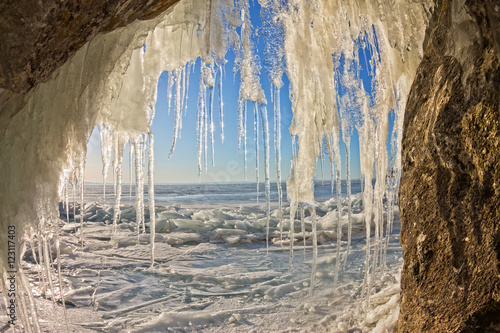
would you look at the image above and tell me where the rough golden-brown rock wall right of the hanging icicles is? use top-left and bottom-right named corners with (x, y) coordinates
top-left (398, 0), bottom-right (500, 332)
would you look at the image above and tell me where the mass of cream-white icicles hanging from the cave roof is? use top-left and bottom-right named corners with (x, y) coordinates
top-left (0, 0), bottom-right (433, 326)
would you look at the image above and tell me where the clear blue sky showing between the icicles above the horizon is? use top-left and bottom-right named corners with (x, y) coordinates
top-left (85, 1), bottom-right (360, 183)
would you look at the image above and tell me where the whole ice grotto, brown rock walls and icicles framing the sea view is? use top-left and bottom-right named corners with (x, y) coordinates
top-left (0, 0), bottom-right (500, 332)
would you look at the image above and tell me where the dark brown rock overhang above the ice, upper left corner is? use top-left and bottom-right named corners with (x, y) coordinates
top-left (0, 0), bottom-right (178, 93)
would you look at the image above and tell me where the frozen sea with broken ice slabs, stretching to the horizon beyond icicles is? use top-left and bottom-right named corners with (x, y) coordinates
top-left (0, 181), bottom-right (402, 332)
